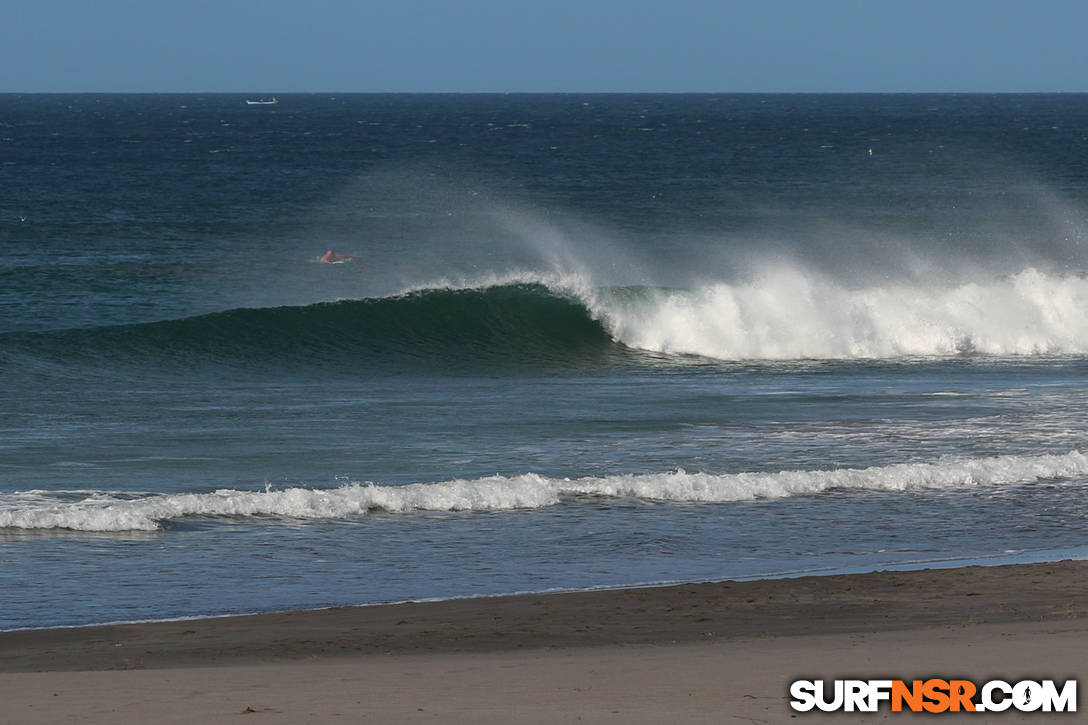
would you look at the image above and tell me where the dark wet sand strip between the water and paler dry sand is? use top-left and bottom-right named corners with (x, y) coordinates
top-left (0, 560), bottom-right (1088, 674)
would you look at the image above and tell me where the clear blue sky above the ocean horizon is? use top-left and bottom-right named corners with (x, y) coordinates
top-left (0, 0), bottom-right (1088, 94)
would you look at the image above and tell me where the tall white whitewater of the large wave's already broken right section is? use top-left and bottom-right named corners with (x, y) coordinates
top-left (583, 266), bottom-right (1088, 360)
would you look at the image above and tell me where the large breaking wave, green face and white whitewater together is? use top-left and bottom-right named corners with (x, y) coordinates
top-left (6, 267), bottom-right (1088, 368)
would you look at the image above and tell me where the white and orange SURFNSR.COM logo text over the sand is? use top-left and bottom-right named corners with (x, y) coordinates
top-left (790, 677), bottom-right (1077, 713)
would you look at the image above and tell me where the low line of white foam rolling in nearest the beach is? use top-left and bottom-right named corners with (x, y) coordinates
top-left (0, 451), bottom-right (1088, 531)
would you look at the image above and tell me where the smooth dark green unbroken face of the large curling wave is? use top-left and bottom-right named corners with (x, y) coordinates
top-left (0, 283), bottom-right (622, 370)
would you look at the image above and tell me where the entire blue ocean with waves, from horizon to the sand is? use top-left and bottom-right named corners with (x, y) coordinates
top-left (0, 94), bottom-right (1088, 629)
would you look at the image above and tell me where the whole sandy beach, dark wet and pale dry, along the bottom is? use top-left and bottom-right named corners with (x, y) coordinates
top-left (0, 561), bottom-right (1088, 723)
